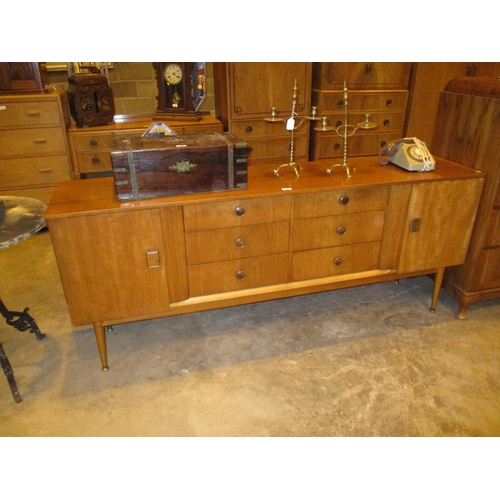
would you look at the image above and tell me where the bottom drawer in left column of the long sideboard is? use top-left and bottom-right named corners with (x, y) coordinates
top-left (188, 254), bottom-right (288, 297)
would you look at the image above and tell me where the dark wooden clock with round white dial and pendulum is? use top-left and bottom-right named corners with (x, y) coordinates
top-left (153, 62), bottom-right (206, 120)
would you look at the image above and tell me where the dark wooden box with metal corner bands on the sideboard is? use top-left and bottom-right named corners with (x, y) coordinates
top-left (111, 132), bottom-right (248, 200)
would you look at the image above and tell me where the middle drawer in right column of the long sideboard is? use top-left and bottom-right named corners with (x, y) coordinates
top-left (292, 210), bottom-right (385, 250)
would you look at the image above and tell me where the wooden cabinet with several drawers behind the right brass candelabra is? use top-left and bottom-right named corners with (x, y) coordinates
top-left (309, 63), bottom-right (411, 160)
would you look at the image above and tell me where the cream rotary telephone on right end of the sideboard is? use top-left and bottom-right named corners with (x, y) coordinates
top-left (378, 137), bottom-right (436, 172)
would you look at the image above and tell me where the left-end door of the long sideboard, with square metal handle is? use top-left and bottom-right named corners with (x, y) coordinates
top-left (49, 210), bottom-right (169, 325)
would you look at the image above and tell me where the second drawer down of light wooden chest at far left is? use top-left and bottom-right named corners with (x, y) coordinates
top-left (0, 127), bottom-right (66, 158)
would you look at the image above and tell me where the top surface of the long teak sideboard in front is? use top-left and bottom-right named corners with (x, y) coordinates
top-left (45, 156), bottom-right (485, 219)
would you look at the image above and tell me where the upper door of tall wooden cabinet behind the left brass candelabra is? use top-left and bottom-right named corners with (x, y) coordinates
top-left (229, 62), bottom-right (312, 119)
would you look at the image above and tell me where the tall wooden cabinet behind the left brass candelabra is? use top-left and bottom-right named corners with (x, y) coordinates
top-left (214, 62), bottom-right (312, 165)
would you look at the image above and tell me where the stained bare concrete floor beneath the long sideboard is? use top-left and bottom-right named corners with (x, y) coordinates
top-left (0, 231), bottom-right (500, 436)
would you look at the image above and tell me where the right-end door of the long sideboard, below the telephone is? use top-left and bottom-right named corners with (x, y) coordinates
top-left (399, 179), bottom-right (483, 273)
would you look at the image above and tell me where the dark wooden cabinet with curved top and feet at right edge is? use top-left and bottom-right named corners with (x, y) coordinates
top-left (433, 77), bottom-right (500, 319)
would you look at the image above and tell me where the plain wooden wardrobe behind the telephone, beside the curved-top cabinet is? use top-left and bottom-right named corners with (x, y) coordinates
top-left (404, 62), bottom-right (500, 146)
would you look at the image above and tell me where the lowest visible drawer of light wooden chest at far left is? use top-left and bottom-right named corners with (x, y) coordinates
top-left (0, 155), bottom-right (71, 189)
